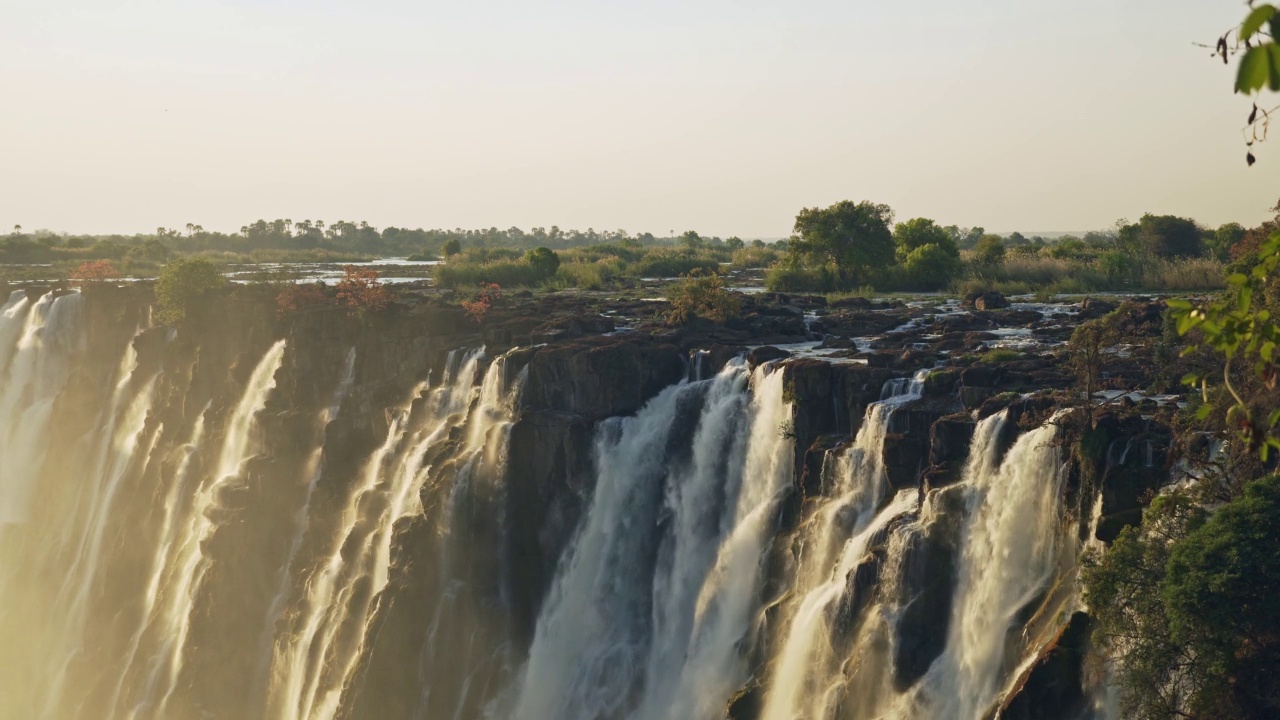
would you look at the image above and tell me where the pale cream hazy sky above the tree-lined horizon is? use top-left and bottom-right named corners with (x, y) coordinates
top-left (0, 0), bottom-right (1280, 237)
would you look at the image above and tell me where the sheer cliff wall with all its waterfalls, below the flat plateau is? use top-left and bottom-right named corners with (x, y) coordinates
top-left (0, 286), bottom-right (1176, 720)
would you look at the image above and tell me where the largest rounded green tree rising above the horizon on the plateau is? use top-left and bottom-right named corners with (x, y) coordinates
top-left (783, 200), bottom-right (893, 287)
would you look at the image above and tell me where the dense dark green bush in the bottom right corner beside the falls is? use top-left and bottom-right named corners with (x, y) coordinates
top-left (1084, 475), bottom-right (1280, 719)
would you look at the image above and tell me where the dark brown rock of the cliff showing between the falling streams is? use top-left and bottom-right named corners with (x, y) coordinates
top-left (5, 280), bottom-right (1172, 720)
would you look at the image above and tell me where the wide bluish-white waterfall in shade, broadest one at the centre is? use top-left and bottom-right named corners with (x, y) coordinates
top-left (509, 361), bottom-right (792, 720)
